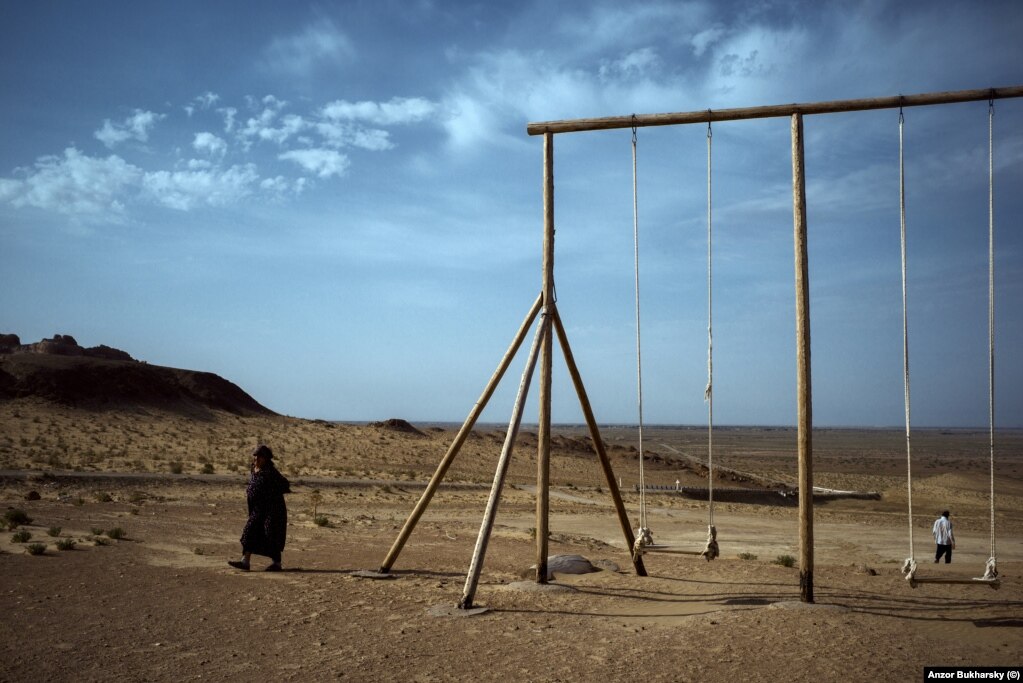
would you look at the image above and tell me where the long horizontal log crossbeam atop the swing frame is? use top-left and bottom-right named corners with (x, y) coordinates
top-left (526, 86), bottom-right (1023, 135)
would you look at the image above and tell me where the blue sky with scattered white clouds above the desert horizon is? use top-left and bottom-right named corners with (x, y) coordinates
top-left (0, 0), bottom-right (1023, 426)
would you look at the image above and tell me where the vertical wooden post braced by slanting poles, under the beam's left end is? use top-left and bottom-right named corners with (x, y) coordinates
top-left (536, 133), bottom-right (554, 584)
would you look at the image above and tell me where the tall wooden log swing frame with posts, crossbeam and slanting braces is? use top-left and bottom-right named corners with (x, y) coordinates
top-left (380, 86), bottom-right (1023, 608)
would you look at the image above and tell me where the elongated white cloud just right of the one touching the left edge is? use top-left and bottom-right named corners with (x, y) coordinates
top-left (142, 164), bottom-right (259, 211)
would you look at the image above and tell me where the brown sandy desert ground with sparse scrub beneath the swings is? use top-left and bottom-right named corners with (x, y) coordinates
top-left (0, 404), bottom-right (1023, 681)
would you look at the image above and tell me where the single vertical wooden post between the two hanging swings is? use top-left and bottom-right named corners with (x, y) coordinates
top-left (792, 113), bottom-right (813, 602)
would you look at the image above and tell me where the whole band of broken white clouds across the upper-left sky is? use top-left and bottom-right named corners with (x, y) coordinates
top-left (0, 92), bottom-right (438, 223)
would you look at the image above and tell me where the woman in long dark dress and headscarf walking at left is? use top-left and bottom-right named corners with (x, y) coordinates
top-left (227, 444), bottom-right (292, 572)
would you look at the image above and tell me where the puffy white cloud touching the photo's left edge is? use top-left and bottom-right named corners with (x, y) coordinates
top-left (0, 147), bottom-right (142, 220)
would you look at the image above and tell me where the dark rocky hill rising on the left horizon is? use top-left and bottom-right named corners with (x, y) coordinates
top-left (0, 334), bottom-right (274, 417)
